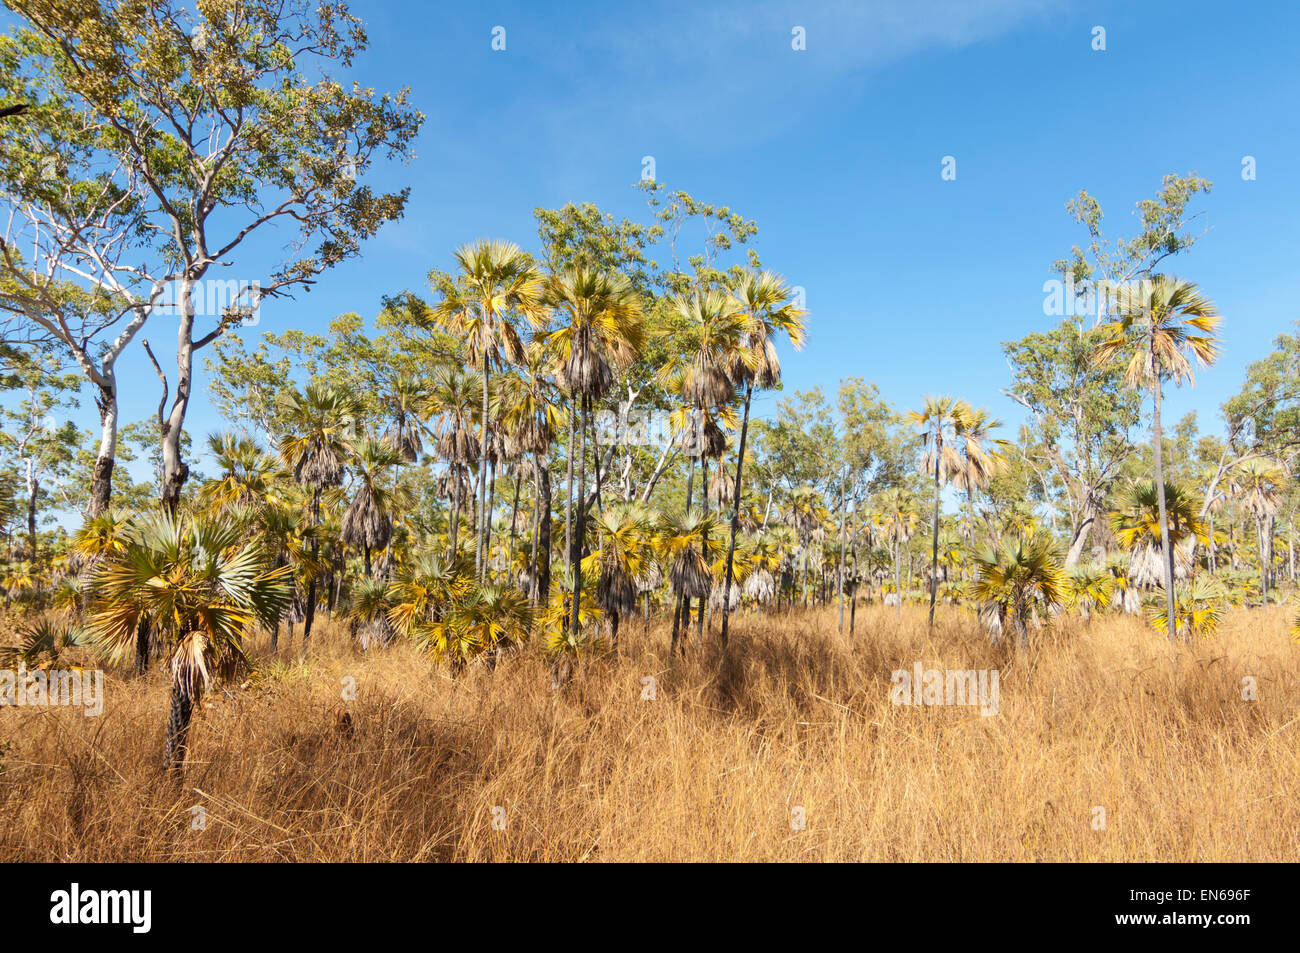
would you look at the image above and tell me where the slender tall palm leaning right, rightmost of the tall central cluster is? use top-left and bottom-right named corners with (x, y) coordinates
top-left (722, 272), bottom-right (807, 646)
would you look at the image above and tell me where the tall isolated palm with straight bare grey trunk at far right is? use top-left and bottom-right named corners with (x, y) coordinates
top-left (1095, 274), bottom-right (1221, 640)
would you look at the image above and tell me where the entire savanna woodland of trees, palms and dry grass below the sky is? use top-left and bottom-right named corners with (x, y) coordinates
top-left (0, 0), bottom-right (1300, 861)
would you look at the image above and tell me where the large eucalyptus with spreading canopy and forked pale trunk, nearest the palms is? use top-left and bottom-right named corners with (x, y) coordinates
top-left (0, 0), bottom-right (424, 511)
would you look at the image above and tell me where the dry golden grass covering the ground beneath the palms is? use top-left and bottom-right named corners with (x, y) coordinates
top-left (0, 607), bottom-right (1300, 861)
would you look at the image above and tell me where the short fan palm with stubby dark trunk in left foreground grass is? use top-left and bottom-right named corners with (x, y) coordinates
top-left (88, 512), bottom-right (293, 770)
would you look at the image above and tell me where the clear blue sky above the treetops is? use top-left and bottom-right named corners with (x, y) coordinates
top-left (22, 0), bottom-right (1300, 473)
